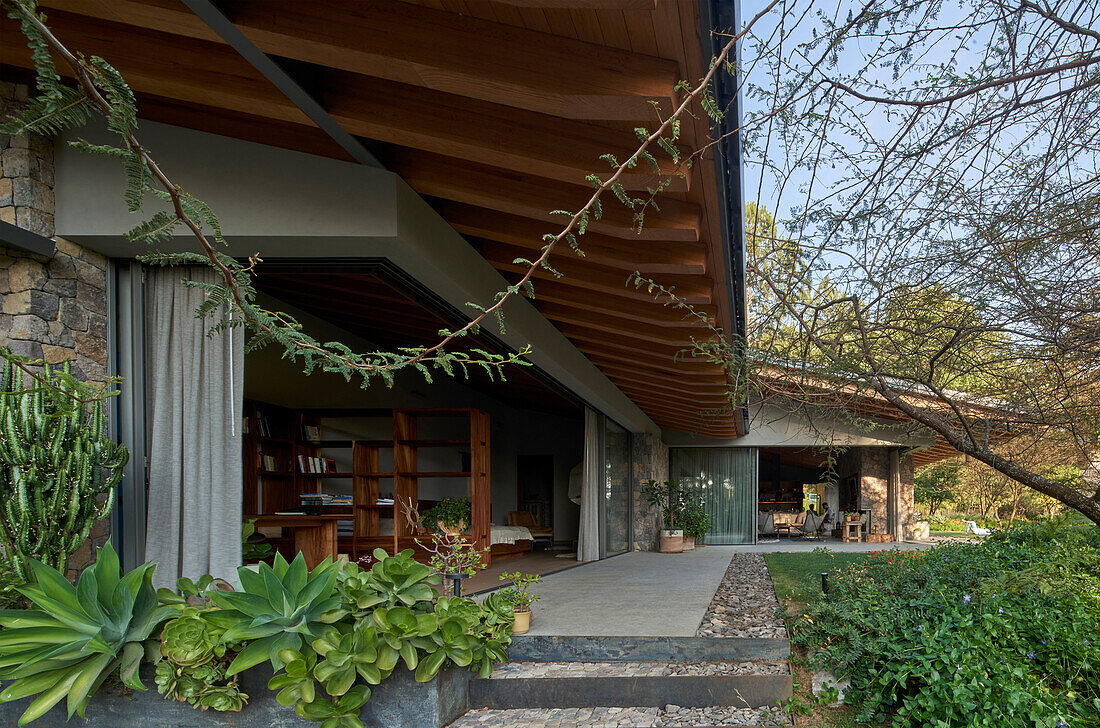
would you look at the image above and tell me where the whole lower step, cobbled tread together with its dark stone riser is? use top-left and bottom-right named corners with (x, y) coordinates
top-left (470, 661), bottom-right (792, 709)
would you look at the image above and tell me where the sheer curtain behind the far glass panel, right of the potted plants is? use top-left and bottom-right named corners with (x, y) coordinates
top-left (669, 448), bottom-right (757, 544)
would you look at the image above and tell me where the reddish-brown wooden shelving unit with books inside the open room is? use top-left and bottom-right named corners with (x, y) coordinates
top-left (244, 401), bottom-right (491, 558)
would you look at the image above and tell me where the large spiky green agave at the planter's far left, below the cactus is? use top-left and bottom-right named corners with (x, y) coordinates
top-left (0, 542), bottom-right (177, 726)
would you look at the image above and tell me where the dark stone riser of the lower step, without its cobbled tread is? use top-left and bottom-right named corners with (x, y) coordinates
top-left (470, 674), bottom-right (794, 709)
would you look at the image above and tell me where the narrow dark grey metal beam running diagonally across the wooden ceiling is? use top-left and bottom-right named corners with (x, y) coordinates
top-left (184, 0), bottom-right (383, 168)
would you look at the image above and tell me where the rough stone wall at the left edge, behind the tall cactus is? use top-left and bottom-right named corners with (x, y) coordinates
top-left (0, 82), bottom-right (110, 570)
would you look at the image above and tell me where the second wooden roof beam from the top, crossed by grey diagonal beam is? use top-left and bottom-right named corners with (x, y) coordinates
top-left (10, 11), bottom-right (686, 190)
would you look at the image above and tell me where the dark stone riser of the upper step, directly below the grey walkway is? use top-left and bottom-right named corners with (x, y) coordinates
top-left (507, 635), bottom-right (791, 662)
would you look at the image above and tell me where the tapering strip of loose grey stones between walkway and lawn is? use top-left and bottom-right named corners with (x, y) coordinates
top-left (695, 553), bottom-right (787, 638)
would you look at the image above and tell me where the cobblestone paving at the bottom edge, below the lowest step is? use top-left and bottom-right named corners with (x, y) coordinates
top-left (451, 705), bottom-right (790, 728)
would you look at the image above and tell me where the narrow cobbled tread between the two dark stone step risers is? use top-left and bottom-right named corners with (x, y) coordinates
top-left (493, 661), bottom-right (788, 680)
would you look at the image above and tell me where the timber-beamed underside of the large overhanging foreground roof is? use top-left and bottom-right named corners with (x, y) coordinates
top-left (8, 0), bottom-right (738, 437)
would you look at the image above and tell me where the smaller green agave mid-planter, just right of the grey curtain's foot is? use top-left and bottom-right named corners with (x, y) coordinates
top-left (207, 553), bottom-right (348, 675)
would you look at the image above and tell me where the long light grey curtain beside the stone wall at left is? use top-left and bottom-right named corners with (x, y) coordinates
top-left (145, 267), bottom-right (244, 587)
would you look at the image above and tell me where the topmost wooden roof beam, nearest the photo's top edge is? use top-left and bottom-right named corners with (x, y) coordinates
top-left (42, 0), bottom-right (680, 121)
